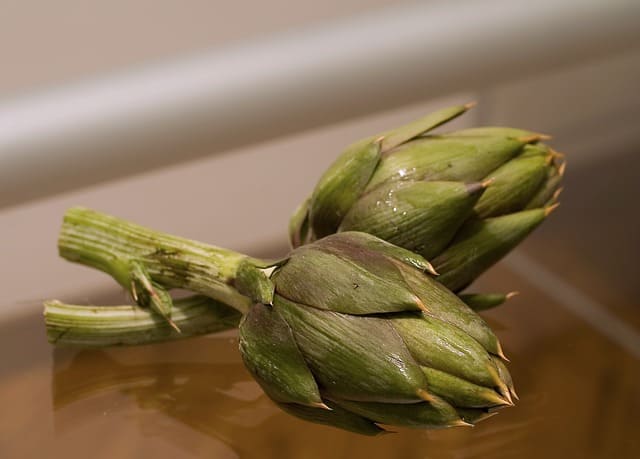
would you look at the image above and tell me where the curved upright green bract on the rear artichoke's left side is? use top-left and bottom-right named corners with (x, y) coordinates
top-left (308, 139), bottom-right (380, 238)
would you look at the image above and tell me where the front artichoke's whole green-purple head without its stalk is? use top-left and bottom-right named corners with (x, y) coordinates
top-left (240, 231), bottom-right (516, 435)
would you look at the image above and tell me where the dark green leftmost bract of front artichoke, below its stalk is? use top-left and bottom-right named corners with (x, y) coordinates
top-left (239, 304), bottom-right (326, 409)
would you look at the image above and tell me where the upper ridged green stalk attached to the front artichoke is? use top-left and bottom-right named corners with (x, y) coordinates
top-left (58, 207), bottom-right (261, 313)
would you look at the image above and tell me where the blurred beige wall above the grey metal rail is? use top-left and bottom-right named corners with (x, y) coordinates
top-left (0, 0), bottom-right (393, 97)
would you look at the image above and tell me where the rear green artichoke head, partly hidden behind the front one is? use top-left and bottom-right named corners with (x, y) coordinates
top-left (289, 104), bottom-right (565, 292)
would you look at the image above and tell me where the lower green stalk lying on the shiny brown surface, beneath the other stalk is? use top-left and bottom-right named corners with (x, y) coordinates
top-left (44, 295), bottom-right (241, 347)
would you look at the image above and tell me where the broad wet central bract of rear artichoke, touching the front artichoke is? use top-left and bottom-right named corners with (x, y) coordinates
top-left (339, 181), bottom-right (485, 258)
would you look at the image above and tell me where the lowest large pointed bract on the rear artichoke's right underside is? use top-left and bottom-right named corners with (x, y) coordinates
top-left (433, 208), bottom-right (551, 292)
